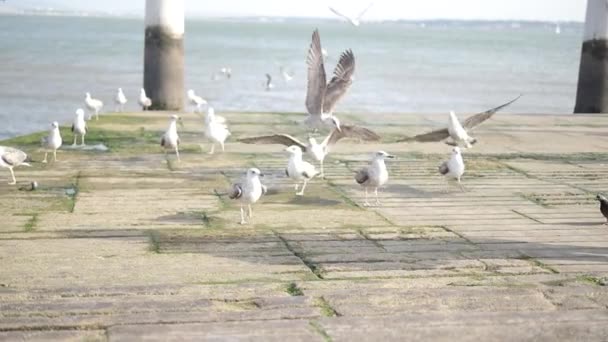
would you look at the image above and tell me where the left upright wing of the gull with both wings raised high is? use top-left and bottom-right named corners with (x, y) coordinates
top-left (306, 30), bottom-right (327, 115)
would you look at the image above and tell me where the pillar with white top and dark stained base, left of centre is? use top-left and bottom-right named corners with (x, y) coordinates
top-left (144, 0), bottom-right (184, 110)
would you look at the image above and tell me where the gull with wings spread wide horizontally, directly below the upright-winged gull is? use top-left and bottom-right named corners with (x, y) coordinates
top-left (238, 125), bottom-right (380, 178)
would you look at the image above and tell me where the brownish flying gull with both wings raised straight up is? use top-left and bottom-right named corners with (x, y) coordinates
top-left (305, 30), bottom-right (355, 129)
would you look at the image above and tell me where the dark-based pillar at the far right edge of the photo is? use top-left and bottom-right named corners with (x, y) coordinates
top-left (574, 0), bottom-right (608, 113)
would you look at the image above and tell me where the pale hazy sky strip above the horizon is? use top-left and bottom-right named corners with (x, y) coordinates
top-left (14, 0), bottom-right (586, 21)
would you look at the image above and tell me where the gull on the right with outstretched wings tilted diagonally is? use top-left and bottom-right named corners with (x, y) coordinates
top-left (397, 95), bottom-right (521, 148)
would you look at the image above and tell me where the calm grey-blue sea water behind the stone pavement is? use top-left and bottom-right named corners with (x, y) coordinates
top-left (0, 16), bottom-right (582, 139)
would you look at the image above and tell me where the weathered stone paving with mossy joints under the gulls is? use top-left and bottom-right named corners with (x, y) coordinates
top-left (0, 112), bottom-right (608, 341)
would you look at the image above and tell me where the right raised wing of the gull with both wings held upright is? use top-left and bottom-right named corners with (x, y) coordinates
top-left (323, 50), bottom-right (355, 113)
